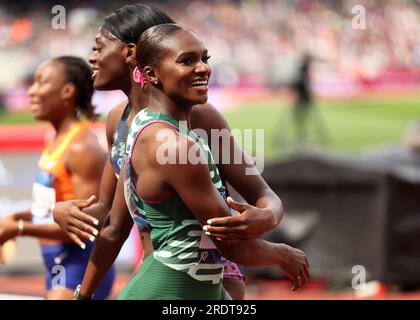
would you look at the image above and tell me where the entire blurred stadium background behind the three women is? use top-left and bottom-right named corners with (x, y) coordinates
top-left (0, 0), bottom-right (420, 299)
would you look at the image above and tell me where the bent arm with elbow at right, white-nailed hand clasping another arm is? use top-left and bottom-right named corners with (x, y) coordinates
top-left (190, 104), bottom-right (283, 243)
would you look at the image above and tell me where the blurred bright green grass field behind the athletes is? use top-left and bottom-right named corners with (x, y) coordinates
top-left (0, 96), bottom-right (420, 160)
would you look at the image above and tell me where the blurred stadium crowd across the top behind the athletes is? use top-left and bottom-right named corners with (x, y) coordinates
top-left (0, 0), bottom-right (420, 110)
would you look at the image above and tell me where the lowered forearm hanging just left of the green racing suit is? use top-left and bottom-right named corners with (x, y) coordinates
top-left (80, 225), bottom-right (129, 297)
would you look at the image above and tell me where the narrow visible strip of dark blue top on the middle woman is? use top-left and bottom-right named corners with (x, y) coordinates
top-left (109, 103), bottom-right (131, 178)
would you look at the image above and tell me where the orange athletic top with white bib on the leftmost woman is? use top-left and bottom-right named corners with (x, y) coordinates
top-left (31, 122), bottom-right (90, 224)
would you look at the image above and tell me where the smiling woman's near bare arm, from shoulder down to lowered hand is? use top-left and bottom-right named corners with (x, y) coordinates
top-left (136, 123), bottom-right (309, 289)
